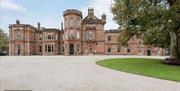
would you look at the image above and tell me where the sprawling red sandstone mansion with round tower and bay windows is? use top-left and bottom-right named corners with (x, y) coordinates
top-left (9, 9), bottom-right (166, 56)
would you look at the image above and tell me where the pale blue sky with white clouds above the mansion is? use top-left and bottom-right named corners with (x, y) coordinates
top-left (0, 0), bottom-right (118, 33)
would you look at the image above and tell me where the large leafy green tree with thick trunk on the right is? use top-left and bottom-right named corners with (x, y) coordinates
top-left (112, 0), bottom-right (180, 59)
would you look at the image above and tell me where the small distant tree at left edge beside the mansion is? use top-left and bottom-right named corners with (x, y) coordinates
top-left (0, 29), bottom-right (8, 53)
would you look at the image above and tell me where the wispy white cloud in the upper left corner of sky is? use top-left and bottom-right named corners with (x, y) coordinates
top-left (0, 0), bottom-right (27, 12)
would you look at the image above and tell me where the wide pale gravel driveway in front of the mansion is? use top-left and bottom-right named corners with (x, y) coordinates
top-left (0, 56), bottom-right (180, 91)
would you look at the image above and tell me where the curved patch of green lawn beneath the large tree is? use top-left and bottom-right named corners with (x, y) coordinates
top-left (96, 58), bottom-right (180, 82)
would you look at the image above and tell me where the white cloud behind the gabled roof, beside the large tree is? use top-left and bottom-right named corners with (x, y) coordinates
top-left (82, 0), bottom-right (119, 29)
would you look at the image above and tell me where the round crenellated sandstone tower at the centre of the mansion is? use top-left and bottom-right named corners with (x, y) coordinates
top-left (64, 9), bottom-right (82, 55)
